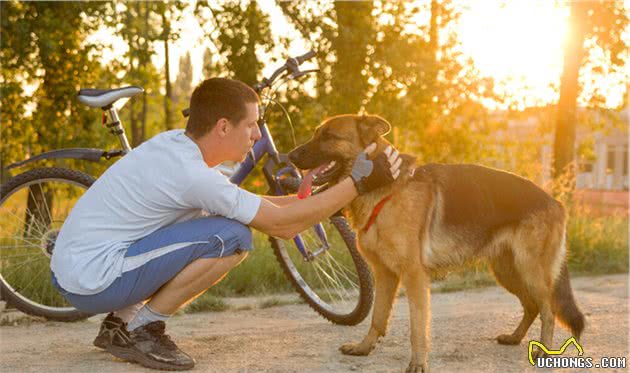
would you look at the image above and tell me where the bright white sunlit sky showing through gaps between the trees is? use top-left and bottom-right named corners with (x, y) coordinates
top-left (87, 0), bottom-right (630, 108)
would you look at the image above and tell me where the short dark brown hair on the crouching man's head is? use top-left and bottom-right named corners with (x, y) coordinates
top-left (186, 78), bottom-right (259, 138)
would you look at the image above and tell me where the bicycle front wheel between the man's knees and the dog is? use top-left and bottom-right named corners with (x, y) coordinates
top-left (270, 216), bottom-right (373, 325)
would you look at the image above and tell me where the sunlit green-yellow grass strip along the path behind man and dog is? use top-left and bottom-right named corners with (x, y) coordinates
top-left (0, 181), bottom-right (629, 312)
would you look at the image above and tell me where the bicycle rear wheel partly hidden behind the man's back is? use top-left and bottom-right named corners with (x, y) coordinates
top-left (0, 167), bottom-right (95, 321)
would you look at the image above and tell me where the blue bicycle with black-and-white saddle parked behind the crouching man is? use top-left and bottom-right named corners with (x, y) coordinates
top-left (0, 51), bottom-right (373, 325)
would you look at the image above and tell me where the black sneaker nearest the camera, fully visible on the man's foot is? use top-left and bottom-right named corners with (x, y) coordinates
top-left (107, 321), bottom-right (195, 370)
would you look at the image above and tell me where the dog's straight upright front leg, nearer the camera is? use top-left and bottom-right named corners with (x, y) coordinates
top-left (403, 267), bottom-right (431, 373)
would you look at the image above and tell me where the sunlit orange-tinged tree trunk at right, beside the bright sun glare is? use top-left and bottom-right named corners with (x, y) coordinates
top-left (553, 1), bottom-right (590, 182)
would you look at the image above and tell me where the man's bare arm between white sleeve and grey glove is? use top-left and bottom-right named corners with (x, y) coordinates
top-left (249, 177), bottom-right (358, 239)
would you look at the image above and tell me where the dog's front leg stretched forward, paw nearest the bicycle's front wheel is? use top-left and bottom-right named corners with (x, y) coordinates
top-left (339, 264), bottom-right (400, 355)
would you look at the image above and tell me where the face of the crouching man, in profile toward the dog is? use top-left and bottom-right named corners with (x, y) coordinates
top-left (225, 102), bottom-right (261, 162)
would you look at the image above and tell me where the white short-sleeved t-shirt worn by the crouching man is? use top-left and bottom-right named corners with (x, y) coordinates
top-left (50, 130), bottom-right (261, 295)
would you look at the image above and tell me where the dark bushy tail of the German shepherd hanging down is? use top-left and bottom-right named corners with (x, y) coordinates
top-left (551, 260), bottom-right (585, 340)
